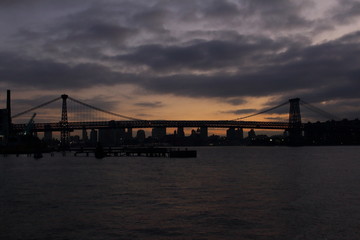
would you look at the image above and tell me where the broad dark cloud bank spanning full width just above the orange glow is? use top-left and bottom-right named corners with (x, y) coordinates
top-left (0, 27), bottom-right (360, 106)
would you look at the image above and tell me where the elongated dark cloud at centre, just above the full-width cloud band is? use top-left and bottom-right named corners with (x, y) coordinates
top-left (116, 36), bottom-right (284, 71)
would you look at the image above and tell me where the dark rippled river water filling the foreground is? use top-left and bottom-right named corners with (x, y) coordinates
top-left (0, 147), bottom-right (360, 240)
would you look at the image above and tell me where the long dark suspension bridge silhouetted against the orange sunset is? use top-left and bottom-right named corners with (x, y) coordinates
top-left (8, 91), bottom-right (344, 147)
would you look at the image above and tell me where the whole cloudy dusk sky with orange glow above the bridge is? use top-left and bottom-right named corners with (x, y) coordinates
top-left (0, 0), bottom-right (360, 123)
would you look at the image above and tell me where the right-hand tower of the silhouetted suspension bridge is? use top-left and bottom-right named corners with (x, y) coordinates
top-left (289, 98), bottom-right (302, 146)
